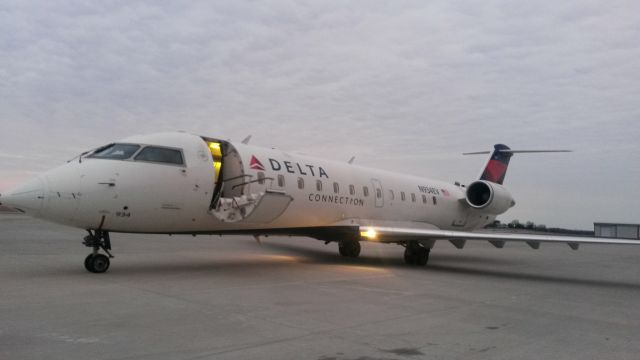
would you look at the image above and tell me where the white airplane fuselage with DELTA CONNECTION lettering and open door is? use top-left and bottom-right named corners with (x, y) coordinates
top-left (3, 133), bottom-right (495, 233)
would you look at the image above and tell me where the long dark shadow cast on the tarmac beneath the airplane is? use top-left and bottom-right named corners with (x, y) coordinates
top-left (27, 243), bottom-right (640, 291)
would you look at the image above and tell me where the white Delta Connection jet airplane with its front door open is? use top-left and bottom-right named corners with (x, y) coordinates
top-left (0, 132), bottom-right (640, 273)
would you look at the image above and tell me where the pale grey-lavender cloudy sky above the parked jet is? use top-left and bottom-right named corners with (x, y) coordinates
top-left (0, 0), bottom-right (640, 229)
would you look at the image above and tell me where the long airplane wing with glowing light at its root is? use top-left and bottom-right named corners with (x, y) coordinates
top-left (360, 226), bottom-right (640, 250)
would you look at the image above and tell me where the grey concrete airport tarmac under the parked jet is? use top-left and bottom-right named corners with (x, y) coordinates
top-left (0, 214), bottom-right (640, 360)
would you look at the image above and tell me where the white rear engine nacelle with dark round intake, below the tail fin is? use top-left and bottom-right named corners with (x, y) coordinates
top-left (467, 180), bottom-right (516, 215)
